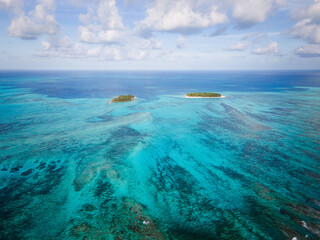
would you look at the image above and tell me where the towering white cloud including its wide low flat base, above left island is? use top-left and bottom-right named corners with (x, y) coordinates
top-left (36, 0), bottom-right (162, 61)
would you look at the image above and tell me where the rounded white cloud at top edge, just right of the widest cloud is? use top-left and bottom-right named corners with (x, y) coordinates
top-left (231, 0), bottom-right (284, 28)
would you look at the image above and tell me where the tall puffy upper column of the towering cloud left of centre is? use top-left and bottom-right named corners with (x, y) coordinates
top-left (79, 0), bottom-right (124, 43)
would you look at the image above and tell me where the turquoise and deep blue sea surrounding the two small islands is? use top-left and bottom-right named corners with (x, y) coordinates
top-left (0, 71), bottom-right (320, 240)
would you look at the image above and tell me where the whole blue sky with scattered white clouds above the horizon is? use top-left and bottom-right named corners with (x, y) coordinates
top-left (0, 0), bottom-right (320, 70)
